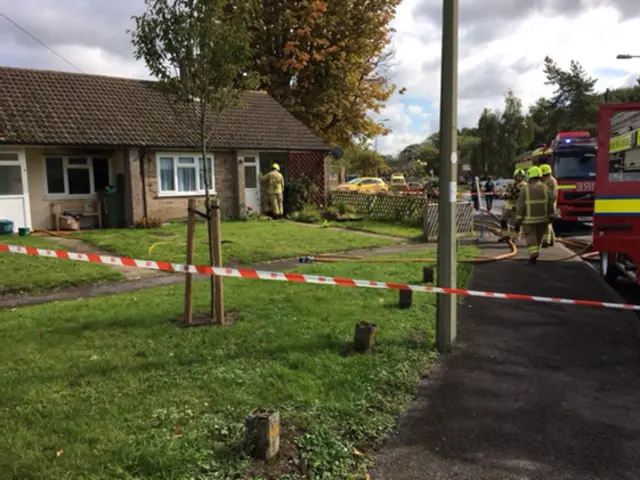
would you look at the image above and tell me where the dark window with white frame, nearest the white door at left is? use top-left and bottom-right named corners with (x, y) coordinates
top-left (45, 156), bottom-right (110, 196)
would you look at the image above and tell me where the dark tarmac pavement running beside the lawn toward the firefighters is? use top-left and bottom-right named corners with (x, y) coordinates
top-left (372, 247), bottom-right (640, 480)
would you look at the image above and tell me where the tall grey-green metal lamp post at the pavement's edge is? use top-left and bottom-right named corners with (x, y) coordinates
top-left (436, 0), bottom-right (458, 351)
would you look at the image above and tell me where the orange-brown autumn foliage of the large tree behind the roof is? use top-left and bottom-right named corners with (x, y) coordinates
top-left (251, 0), bottom-right (400, 146)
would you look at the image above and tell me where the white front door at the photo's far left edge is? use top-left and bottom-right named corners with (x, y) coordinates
top-left (0, 150), bottom-right (31, 232)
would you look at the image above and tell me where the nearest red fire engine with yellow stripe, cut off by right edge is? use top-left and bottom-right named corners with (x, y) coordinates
top-left (593, 103), bottom-right (640, 284)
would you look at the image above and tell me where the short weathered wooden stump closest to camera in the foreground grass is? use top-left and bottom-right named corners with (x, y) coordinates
top-left (245, 409), bottom-right (280, 460)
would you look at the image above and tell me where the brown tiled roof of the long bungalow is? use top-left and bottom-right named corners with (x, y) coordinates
top-left (0, 67), bottom-right (329, 150)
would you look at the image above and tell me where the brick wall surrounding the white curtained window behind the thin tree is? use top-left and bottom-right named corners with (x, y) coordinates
top-left (144, 152), bottom-right (244, 220)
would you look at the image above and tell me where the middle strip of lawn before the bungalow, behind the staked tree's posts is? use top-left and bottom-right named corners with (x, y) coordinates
top-left (78, 220), bottom-right (394, 265)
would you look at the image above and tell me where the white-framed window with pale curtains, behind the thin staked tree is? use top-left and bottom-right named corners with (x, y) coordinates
top-left (157, 153), bottom-right (215, 196)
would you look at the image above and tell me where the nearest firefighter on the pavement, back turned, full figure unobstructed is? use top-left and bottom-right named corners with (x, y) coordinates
top-left (515, 166), bottom-right (555, 265)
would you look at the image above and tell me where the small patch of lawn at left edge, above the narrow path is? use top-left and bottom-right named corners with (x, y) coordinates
top-left (0, 236), bottom-right (122, 294)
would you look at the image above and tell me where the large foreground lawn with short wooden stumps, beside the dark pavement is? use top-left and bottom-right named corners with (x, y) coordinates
top-left (0, 248), bottom-right (477, 480)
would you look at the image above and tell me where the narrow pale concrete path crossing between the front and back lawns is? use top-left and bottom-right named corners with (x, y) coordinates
top-left (0, 242), bottom-right (435, 309)
